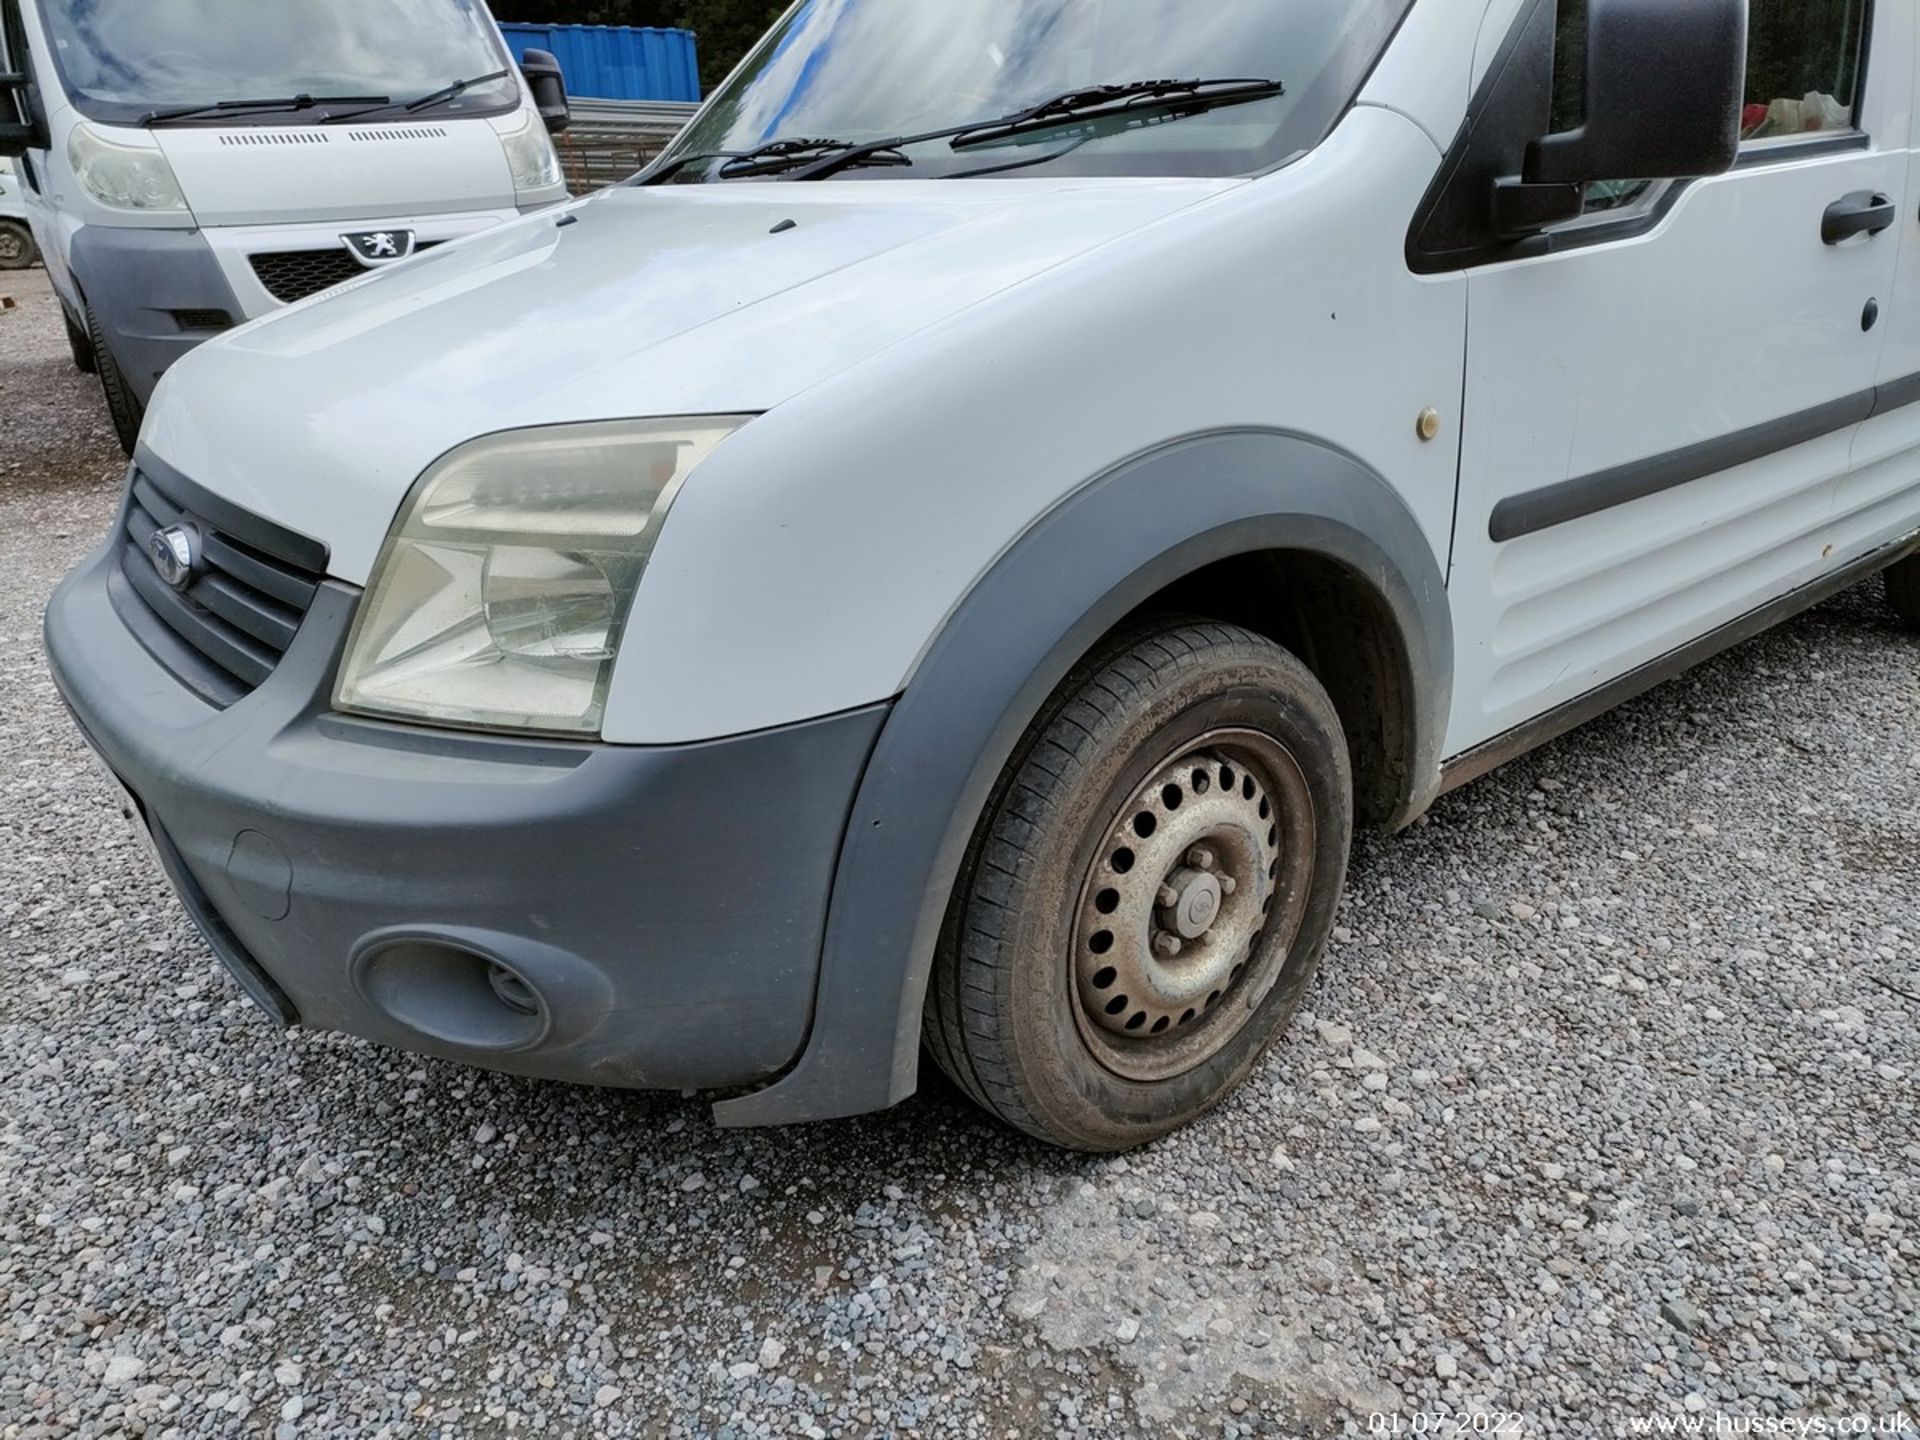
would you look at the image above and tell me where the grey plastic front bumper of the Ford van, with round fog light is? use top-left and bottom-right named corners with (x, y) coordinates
top-left (46, 543), bottom-right (885, 1089)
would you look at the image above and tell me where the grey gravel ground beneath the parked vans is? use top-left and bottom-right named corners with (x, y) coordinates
top-left (0, 275), bottom-right (1920, 1440)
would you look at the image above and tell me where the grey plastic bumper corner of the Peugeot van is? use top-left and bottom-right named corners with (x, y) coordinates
top-left (73, 225), bottom-right (246, 405)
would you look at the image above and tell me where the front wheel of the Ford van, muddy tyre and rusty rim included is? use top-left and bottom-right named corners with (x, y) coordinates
top-left (925, 620), bottom-right (1354, 1152)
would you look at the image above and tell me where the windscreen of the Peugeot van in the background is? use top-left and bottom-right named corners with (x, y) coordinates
top-left (38, 0), bottom-right (520, 125)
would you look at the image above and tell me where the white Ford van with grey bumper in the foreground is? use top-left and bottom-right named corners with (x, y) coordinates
top-left (48, 0), bottom-right (1920, 1150)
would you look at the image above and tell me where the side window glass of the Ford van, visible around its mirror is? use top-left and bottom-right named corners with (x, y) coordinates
top-left (1553, 0), bottom-right (1872, 215)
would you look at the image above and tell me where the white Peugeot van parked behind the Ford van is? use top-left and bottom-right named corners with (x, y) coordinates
top-left (0, 0), bottom-right (566, 453)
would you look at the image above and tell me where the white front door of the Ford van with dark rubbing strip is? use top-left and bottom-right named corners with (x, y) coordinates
top-left (1436, 0), bottom-right (1896, 755)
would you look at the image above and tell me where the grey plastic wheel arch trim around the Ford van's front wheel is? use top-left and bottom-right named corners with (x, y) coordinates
top-left (714, 430), bottom-right (1453, 1125)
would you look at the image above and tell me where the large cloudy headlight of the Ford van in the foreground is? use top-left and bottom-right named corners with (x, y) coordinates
top-left (334, 415), bottom-right (747, 735)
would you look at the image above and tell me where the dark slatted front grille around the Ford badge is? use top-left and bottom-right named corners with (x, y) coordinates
top-left (109, 468), bottom-right (326, 707)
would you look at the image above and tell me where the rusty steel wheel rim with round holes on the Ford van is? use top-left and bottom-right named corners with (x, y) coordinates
top-left (1069, 730), bottom-right (1317, 1083)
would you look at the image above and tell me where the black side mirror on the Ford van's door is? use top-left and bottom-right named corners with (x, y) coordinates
top-left (1494, 0), bottom-right (1747, 234)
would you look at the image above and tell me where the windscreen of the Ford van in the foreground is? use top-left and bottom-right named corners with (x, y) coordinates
top-left (662, 0), bottom-right (1409, 182)
